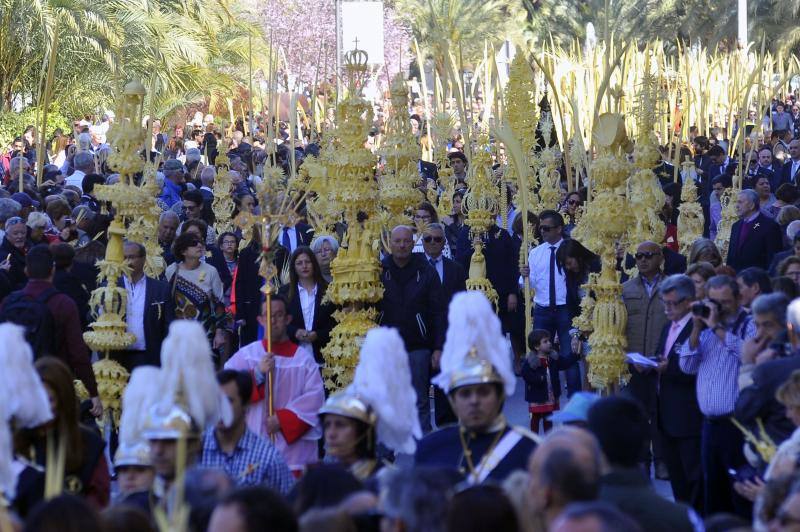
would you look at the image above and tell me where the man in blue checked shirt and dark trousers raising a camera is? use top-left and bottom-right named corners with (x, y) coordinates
top-left (680, 275), bottom-right (756, 515)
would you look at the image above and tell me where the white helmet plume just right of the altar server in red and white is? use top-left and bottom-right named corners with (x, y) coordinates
top-left (350, 327), bottom-right (422, 454)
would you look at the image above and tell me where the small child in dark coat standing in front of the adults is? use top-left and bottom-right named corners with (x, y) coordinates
top-left (522, 329), bottom-right (561, 434)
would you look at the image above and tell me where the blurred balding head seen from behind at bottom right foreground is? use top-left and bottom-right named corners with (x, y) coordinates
top-left (528, 427), bottom-right (603, 529)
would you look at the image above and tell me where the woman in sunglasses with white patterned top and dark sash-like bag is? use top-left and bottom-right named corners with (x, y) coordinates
top-left (166, 232), bottom-right (229, 349)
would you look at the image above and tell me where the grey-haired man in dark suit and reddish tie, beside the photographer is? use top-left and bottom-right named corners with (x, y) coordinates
top-left (656, 275), bottom-right (703, 511)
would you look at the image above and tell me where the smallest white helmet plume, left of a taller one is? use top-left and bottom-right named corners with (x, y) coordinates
top-left (119, 366), bottom-right (161, 444)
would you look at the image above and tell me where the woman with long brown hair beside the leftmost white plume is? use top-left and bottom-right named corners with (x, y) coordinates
top-left (16, 357), bottom-right (111, 509)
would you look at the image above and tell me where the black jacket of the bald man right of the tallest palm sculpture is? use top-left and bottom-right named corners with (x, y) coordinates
top-left (378, 253), bottom-right (446, 351)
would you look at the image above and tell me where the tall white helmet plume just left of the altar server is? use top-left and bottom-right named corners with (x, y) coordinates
top-left (161, 320), bottom-right (233, 430)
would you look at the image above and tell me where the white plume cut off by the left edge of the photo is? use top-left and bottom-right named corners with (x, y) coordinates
top-left (0, 323), bottom-right (53, 427)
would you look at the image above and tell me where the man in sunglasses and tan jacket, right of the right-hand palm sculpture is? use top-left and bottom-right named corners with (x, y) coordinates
top-left (622, 242), bottom-right (667, 478)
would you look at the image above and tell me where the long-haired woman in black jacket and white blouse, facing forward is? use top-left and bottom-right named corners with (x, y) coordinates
top-left (280, 246), bottom-right (333, 363)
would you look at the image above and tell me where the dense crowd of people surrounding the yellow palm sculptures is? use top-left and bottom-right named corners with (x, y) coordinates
top-left (0, 93), bottom-right (800, 531)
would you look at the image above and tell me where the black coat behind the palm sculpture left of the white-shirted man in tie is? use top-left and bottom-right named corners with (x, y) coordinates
top-left (456, 225), bottom-right (519, 313)
